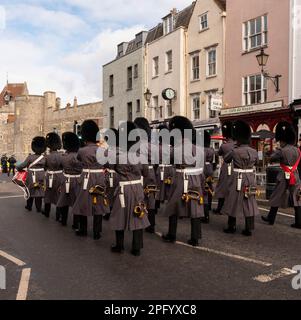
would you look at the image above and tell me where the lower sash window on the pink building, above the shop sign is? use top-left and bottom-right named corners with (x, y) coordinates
top-left (243, 74), bottom-right (267, 106)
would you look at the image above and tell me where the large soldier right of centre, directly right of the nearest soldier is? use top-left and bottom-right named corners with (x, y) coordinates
top-left (162, 116), bottom-right (204, 246)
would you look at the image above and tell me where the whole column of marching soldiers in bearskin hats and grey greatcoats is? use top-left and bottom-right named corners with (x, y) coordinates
top-left (13, 116), bottom-right (301, 256)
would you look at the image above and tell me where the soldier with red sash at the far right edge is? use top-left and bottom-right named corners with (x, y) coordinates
top-left (262, 122), bottom-right (301, 229)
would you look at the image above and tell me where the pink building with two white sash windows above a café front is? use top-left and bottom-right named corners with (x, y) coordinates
top-left (221, 0), bottom-right (294, 132)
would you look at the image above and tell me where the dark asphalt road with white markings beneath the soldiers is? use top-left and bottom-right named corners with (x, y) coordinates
top-left (0, 172), bottom-right (301, 300)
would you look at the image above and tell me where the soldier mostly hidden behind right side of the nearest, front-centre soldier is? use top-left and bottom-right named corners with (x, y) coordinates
top-left (134, 118), bottom-right (159, 234)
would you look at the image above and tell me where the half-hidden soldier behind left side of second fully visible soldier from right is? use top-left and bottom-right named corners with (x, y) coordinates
top-left (213, 121), bottom-right (235, 214)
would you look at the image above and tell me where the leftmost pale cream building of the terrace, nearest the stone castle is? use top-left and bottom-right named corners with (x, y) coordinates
top-left (103, 31), bottom-right (147, 128)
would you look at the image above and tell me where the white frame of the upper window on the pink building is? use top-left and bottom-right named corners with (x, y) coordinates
top-left (242, 14), bottom-right (268, 52)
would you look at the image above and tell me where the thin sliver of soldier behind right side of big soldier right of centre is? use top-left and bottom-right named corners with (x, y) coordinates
top-left (202, 130), bottom-right (215, 224)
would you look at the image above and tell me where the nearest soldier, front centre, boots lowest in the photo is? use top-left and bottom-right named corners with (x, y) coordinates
top-left (110, 122), bottom-right (150, 256)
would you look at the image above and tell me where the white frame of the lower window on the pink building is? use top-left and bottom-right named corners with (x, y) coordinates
top-left (242, 74), bottom-right (268, 106)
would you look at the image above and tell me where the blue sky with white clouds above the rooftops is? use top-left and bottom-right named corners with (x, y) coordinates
top-left (0, 0), bottom-right (192, 104)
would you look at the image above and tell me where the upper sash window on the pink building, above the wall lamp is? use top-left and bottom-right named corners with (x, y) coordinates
top-left (243, 15), bottom-right (268, 51)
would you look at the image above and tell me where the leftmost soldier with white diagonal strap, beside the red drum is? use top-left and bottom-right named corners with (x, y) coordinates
top-left (17, 137), bottom-right (46, 212)
